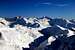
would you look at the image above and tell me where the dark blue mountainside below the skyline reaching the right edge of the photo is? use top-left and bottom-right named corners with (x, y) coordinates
top-left (49, 18), bottom-right (75, 29)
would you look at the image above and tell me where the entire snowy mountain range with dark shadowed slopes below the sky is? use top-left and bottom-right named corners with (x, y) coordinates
top-left (0, 16), bottom-right (75, 50)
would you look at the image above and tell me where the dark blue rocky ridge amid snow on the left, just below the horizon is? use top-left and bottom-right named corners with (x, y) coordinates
top-left (5, 16), bottom-right (40, 28)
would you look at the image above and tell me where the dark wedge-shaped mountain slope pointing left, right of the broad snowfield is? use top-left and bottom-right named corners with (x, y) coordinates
top-left (39, 26), bottom-right (68, 36)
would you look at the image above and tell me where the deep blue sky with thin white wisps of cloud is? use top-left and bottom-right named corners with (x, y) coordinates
top-left (0, 0), bottom-right (75, 18)
